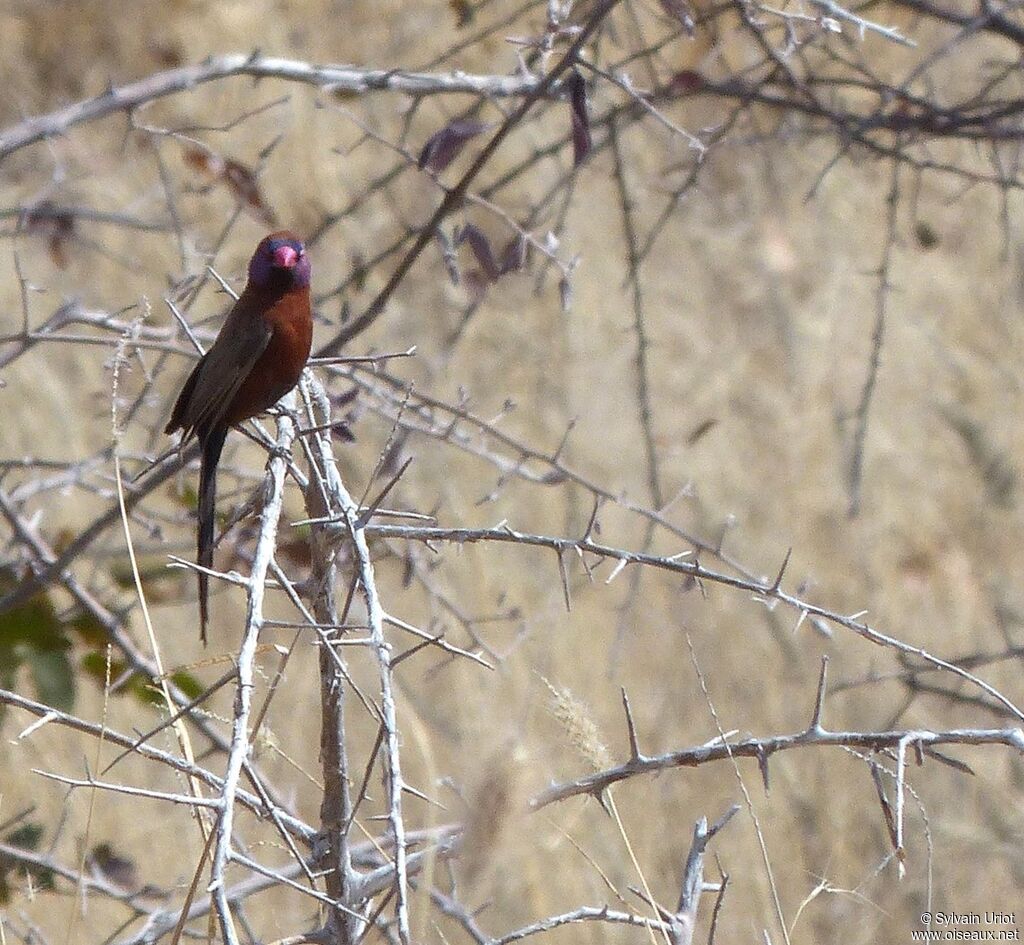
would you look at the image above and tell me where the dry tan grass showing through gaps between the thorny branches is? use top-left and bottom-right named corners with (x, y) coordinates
top-left (0, 0), bottom-right (1024, 943)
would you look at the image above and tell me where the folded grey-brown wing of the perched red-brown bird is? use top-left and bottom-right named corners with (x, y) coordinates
top-left (179, 296), bottom-right (273, 433)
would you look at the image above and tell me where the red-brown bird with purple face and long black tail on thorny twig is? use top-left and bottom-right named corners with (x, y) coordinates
top-left (164, 229), bottom-right (313, 644)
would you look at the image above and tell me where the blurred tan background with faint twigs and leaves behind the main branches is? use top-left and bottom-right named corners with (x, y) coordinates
top-left (0, 0), bottom-right (1024, 943)
